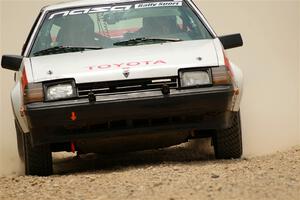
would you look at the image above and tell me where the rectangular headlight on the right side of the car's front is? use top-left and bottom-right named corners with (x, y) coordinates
top-left (179, 70), bottom-right (212, 87)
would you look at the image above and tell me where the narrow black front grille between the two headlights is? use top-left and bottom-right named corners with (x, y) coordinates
top-left (77, 77), bottom-right (177, 97)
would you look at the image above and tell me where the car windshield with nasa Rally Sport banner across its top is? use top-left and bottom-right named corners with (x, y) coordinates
top-left (30, 0), bottom-right (212, 56)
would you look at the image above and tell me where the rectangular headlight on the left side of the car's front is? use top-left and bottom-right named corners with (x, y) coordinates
top-left (45, 82), bottom-right (76, 101)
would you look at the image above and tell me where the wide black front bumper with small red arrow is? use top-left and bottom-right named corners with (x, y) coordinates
top-left (26, 86), bottom-right (233, 145)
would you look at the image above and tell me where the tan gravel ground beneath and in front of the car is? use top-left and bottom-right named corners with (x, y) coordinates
top-left (0, 140), bottom-right (300, 200)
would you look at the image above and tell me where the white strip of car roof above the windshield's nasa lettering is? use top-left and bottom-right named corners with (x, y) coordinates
top-left (43, 0), bottom-right (159, 11)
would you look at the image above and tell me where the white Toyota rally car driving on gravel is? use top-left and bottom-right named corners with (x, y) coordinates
top-left (1, 0), bottom-right (243, 175)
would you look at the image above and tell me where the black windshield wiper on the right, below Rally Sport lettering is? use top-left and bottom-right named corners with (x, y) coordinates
top-left (114, 37), bottom-right (182, 46)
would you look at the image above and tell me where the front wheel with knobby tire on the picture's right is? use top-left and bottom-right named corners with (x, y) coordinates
top-left (213, 111), bottom-right (243, 159)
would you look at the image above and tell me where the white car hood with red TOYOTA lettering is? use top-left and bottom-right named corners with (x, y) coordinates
top-left (30, 39), bottom-right (218, 83)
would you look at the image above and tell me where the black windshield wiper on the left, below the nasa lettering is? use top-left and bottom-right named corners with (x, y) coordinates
top-left (33, 46), bottom-right (103, 56)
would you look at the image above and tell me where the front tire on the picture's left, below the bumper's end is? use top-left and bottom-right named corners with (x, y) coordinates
top-left (22, 133), bottom-right (53, 176)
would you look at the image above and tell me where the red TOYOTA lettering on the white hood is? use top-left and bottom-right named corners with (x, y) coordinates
top-left (88, 60), bottom-right (167, 70)
